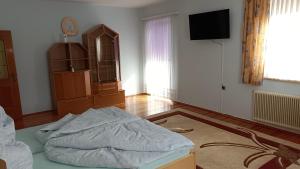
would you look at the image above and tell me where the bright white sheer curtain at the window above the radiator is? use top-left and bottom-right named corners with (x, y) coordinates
top-left (265, 0), bottom-right (300, 81)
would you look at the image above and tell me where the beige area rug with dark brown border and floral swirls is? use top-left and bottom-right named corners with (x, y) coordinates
top-left (148, 108), bottom-right (300, 169)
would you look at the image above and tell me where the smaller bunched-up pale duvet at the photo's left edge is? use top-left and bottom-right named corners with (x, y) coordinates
top-left (0, 106), bottom-right (33, 169)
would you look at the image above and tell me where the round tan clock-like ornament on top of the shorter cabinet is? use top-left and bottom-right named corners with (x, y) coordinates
top-left (61, 17), bottom-right (79, 36)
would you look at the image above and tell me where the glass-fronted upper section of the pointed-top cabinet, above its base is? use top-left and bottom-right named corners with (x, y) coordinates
top-left (82, 24), bottom-right (121, 83)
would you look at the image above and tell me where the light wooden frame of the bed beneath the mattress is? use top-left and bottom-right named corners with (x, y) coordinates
top-left (0, 151), bottom-right (196, 169)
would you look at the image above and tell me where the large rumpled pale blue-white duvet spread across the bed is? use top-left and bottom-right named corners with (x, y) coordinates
top-left (38, 107), bottom-right (193, 168)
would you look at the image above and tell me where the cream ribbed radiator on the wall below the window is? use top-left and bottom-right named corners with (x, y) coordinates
top-left (253, 91), bottom-right (300, 130)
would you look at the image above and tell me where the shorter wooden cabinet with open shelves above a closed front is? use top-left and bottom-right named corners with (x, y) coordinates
top-left (48, 42), bottom-right (92, 115)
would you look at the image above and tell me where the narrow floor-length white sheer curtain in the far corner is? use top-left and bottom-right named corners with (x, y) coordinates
top-left (144, 16), bottom-right (177, 99)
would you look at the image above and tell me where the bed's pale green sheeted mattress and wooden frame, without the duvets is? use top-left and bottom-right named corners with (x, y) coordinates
top-left (16, 117), bottom-right (196, 169)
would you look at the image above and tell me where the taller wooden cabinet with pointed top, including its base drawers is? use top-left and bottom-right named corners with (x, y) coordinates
top-left (82, 24), bottom-right (125, 110)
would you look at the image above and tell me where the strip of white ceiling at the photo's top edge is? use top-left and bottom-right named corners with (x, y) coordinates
top-left (51, 0), bottom-right (165, 8)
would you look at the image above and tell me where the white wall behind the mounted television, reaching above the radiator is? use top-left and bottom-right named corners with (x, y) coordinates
top-left (140, 0), bottom-right (300, 119)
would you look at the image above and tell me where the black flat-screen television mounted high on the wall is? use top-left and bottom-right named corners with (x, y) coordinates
top-left (189, 9), bottom-right (230, 40)
